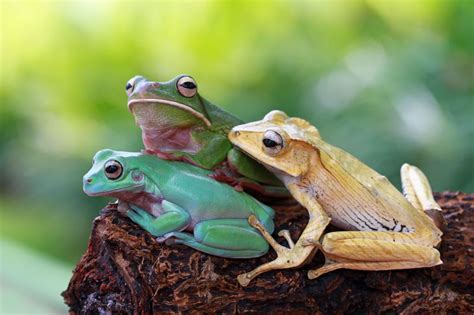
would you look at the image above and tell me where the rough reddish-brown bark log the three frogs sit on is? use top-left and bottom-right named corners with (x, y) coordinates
top-left (63, 192), bottom-right (474, 314)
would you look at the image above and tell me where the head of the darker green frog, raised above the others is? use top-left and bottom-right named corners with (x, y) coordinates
top-left (125, 75), bottom-right (211, 129)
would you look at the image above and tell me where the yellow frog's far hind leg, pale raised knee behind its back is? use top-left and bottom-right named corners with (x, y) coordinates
top-left (400, 163), bottom-right (446, 229)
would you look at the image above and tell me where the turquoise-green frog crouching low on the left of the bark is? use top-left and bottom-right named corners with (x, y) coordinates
top-left (83, 149), bottom-right (275, 259)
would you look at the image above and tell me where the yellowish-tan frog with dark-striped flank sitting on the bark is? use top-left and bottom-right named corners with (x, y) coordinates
top-left (229, 110), bottom-right (444, 286)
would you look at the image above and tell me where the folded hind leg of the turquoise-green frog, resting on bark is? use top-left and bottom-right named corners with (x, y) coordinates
top-left (165, 219), bottom-right (269, 258)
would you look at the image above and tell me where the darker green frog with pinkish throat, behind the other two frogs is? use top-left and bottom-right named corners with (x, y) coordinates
top-left (125, 74), bottom-right (289, 197)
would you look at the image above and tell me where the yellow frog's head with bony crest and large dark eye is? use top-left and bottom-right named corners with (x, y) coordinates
top-left (229, 110), bottom-right (320, 177)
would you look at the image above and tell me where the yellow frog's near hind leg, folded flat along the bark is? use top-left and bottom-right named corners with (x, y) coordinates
top-left (308, 231), bottom-right (442, 279)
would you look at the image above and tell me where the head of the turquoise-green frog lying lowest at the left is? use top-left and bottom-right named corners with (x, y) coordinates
top-left (83, 149), bottom-right (145, 197)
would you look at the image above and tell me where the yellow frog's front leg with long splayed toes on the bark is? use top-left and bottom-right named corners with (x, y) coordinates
top-left (237, 183), bottom-right (330, 286)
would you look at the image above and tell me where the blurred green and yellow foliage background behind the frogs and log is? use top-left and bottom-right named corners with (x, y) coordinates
top-left (0, 0), bottom-right (474, 313)
